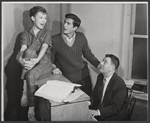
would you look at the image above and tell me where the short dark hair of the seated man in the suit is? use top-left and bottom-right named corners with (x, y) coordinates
top-left (105, 54), bottom-right (120, 70)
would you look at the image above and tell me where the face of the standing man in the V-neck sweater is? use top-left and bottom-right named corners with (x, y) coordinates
top-left (64, 18), bottom-right (77, 34)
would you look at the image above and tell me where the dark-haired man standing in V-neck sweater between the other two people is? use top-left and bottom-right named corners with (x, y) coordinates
top-left (52, 13), bottom-right (100, 95)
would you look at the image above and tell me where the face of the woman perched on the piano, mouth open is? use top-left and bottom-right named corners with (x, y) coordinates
top-left (32, 12), bottom-right (47, 29)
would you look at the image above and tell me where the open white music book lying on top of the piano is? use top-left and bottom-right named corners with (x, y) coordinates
top-left (35, 80), bottom-right (81, 102)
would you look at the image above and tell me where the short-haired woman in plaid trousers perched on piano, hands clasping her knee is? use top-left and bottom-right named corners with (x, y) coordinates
top-left (17, 6), bottom-right (61, 121)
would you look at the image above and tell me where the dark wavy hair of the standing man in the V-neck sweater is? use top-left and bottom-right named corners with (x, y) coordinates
top-left (65, 13), bottom-right (81, 28)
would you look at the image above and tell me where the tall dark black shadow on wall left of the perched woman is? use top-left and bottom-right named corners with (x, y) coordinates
top-left (4, 34), bottom-right (27, 121)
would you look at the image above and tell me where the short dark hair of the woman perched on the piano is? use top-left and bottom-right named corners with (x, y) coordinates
top-left (29, 6), bottom-right (47, 17)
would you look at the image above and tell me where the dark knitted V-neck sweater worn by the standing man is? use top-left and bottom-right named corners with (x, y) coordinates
top-left (52, 32), bottom-right (100, 82)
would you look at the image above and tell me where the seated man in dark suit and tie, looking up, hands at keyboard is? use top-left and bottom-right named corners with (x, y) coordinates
top-left (89, 54), bottom-right (127, 121)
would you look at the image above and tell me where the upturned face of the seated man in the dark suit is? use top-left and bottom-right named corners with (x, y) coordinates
top-left (100, 57), bottom-right (113, 74)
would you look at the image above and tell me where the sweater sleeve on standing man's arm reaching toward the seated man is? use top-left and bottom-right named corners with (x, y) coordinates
top-left (82, 34), bottom-right (100, 67)
